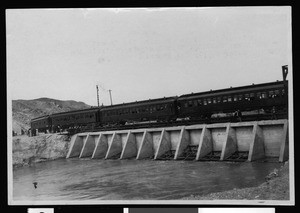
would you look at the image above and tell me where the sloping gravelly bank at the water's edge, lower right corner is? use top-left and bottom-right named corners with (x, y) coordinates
top-left (183, 162), bottom-right (290, 200)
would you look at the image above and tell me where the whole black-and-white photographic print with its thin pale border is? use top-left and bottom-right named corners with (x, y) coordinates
top-left (6, 6), bottom-right (295, 205)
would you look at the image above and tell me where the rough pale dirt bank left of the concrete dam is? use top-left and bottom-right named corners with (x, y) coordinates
top-left (12, 134), bottom-right (70, 167)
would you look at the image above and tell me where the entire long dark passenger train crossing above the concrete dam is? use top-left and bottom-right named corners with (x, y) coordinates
top-left (31, 66), bottom-right (288, 135)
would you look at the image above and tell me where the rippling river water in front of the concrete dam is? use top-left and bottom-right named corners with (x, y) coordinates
top-left (13, 158), bottom-right (281, 201)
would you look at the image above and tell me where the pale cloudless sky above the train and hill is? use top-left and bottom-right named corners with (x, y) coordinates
top-left (6, 7), bottom-right (292, 106)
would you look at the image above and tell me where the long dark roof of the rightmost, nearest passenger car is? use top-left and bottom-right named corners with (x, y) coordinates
top-left (178, 81), bottom-right (284, 100)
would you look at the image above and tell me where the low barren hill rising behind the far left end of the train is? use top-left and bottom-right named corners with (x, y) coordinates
top-left (12, 98), bottom-right (91, 134)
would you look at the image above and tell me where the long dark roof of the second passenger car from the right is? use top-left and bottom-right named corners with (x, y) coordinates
top-left (101, 96), bottom-right (177, 111)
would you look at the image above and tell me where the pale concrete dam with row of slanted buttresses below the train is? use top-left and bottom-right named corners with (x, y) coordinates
top-left (66, 119), bottom-right (289, 162)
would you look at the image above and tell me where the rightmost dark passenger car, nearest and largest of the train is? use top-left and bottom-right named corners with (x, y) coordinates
top-left (177, 81), bottom-right (287, 118)
